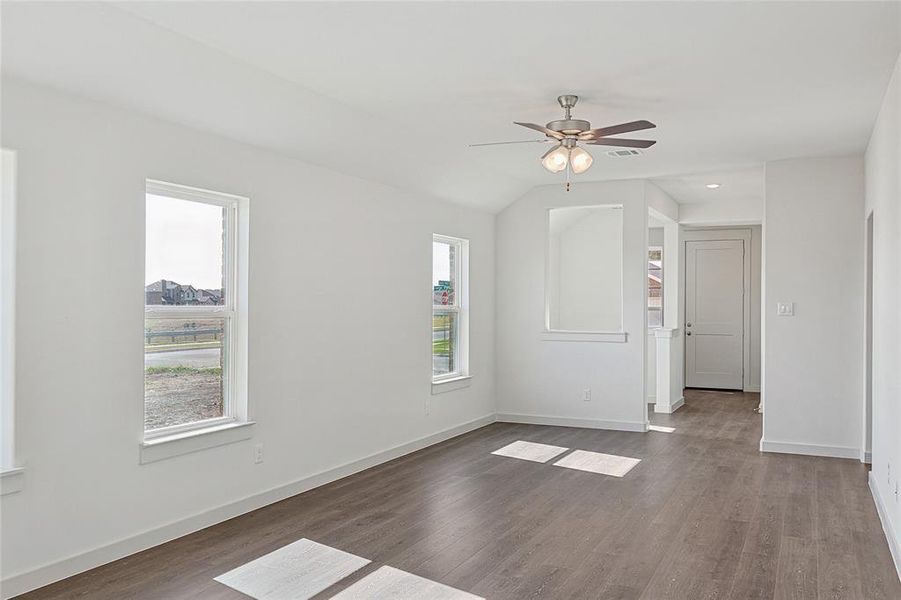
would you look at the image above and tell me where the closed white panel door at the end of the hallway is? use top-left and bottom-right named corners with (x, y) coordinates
top-left (685, 240), bottom-right (745, 390)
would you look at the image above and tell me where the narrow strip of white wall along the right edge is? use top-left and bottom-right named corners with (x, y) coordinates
top-left (858, 55), bottom-right (901, 574)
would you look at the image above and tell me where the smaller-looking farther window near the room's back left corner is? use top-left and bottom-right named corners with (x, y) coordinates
top-left (432, 235), bottom-right (469, 382)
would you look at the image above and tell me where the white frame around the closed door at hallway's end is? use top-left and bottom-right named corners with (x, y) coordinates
top-left (679, 227), bottom-right (752, 392)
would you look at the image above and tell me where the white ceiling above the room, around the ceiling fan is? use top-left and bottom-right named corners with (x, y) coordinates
top-left (2, 2), bottom-right (901, 211)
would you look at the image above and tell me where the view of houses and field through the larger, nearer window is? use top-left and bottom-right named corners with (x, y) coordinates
top-left (144, 185), bottom-right (232, 431)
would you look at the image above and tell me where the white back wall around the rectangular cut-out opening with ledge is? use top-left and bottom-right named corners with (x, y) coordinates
top-left (496, 181), bottom-right (647, 430)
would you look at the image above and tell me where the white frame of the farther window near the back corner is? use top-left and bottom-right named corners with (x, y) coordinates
top-left (431, 233), bottom-right (470, 384)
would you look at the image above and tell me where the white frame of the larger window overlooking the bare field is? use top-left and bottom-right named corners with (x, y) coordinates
top-left (141, 179), bottom-right (249, 442)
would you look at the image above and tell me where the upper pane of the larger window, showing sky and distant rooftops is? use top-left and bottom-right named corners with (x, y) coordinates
top-left (144, 194), bottom-right (225, 306)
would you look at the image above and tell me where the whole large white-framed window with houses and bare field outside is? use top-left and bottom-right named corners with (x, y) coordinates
top-left (143, 181), bottom-right (246, 439)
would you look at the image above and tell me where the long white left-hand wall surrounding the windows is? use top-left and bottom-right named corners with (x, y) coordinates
top-left (2, 80), bottom-right (500, 594)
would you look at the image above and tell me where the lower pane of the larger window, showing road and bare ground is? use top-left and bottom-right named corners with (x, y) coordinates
top-left (144, 318), bottom-right (225, 430)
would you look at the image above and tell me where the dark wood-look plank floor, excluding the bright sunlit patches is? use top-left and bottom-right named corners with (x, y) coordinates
top-left (17, 391), bottom-right (901, 600)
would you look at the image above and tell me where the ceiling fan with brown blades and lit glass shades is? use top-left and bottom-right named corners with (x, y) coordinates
top-left (470, 94), bottom-right (657, 191)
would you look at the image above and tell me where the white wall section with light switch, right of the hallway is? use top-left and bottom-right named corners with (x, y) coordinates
top-left (761, 156), bottom-right (864, 458)
